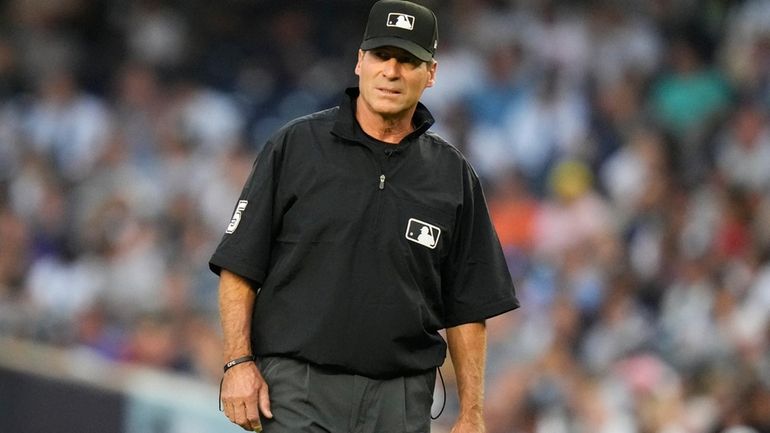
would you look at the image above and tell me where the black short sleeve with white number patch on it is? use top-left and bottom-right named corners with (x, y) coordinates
top-left (209, 141), bottom-right (282, 287)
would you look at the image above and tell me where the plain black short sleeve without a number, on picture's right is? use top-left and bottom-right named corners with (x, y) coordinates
top-left (443, 166), bottom-right (519, 328)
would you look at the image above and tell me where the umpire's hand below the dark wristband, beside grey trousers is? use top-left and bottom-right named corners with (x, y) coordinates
top-left (222, 362), bottom-right (273, 432)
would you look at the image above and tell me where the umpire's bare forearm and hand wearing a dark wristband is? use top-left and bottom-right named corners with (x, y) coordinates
top-left (219, 269), bottom-right (273, 431)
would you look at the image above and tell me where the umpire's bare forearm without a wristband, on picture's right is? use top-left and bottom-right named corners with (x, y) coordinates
top-left (446, 321), bottom-right (487, 433)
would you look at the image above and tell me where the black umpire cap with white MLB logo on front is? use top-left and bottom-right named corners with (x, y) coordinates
top-left (361, 0), bottom-right (438, 62)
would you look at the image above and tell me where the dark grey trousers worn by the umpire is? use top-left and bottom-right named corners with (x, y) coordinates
top-left (259, 357), bottom-right (436, 433)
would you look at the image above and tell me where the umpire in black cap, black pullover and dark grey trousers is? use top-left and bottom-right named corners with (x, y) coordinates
top-left (210, 0), bottom-right (518, 433)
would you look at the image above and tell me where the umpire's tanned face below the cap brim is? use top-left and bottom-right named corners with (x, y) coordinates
top-left (356, 47), bottom-right (436, 118)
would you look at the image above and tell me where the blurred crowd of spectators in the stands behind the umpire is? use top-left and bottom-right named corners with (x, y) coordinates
top-left (0, 0), bottom-right (770, 433)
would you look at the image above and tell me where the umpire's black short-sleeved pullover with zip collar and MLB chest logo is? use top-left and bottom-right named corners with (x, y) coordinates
top-left (210, 89), bottom-right (518, 377)
